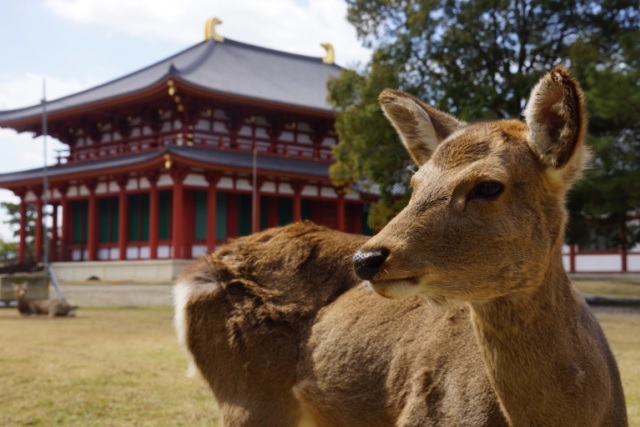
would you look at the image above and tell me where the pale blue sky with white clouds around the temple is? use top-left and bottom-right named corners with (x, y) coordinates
top-left (0, 0), bottom-right (370, 241)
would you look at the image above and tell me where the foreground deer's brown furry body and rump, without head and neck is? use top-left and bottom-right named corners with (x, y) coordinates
top-left (175, 223), bottom-right (506, 427)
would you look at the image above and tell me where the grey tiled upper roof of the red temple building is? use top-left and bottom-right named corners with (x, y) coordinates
top-left (0, 39), bottom-right (341, 126)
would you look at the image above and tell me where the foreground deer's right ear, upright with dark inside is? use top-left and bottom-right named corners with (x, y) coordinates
top-left (524, 67), bottom-right (588, 181)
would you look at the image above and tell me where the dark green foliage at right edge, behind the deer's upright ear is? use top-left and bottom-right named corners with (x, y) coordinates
top-left (568, 28), bottom-right (640, 249)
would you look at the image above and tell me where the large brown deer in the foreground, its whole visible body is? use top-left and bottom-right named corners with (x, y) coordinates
top-left (174, 68), bottom-right (627, 426)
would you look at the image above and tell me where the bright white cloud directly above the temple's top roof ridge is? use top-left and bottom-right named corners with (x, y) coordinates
top-left (45, 0), bottom-right (370, 66)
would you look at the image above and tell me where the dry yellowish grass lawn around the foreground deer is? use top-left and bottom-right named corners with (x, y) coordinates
top-left (0, 302), bottom-right (640, 427)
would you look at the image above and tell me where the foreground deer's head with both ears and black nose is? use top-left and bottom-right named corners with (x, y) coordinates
top-left (354, 67), bottom-right (588, 302)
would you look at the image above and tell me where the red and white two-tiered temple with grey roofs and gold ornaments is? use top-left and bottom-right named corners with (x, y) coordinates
top-left (0, 20), bottom-right (369, 280)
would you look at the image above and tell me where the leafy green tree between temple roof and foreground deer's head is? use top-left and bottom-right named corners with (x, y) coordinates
top-left (329, 0), bottom-right (640, 231)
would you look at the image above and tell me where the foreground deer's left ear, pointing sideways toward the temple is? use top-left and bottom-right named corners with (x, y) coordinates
top-left (379, 89), bottom-right (464, 166)
